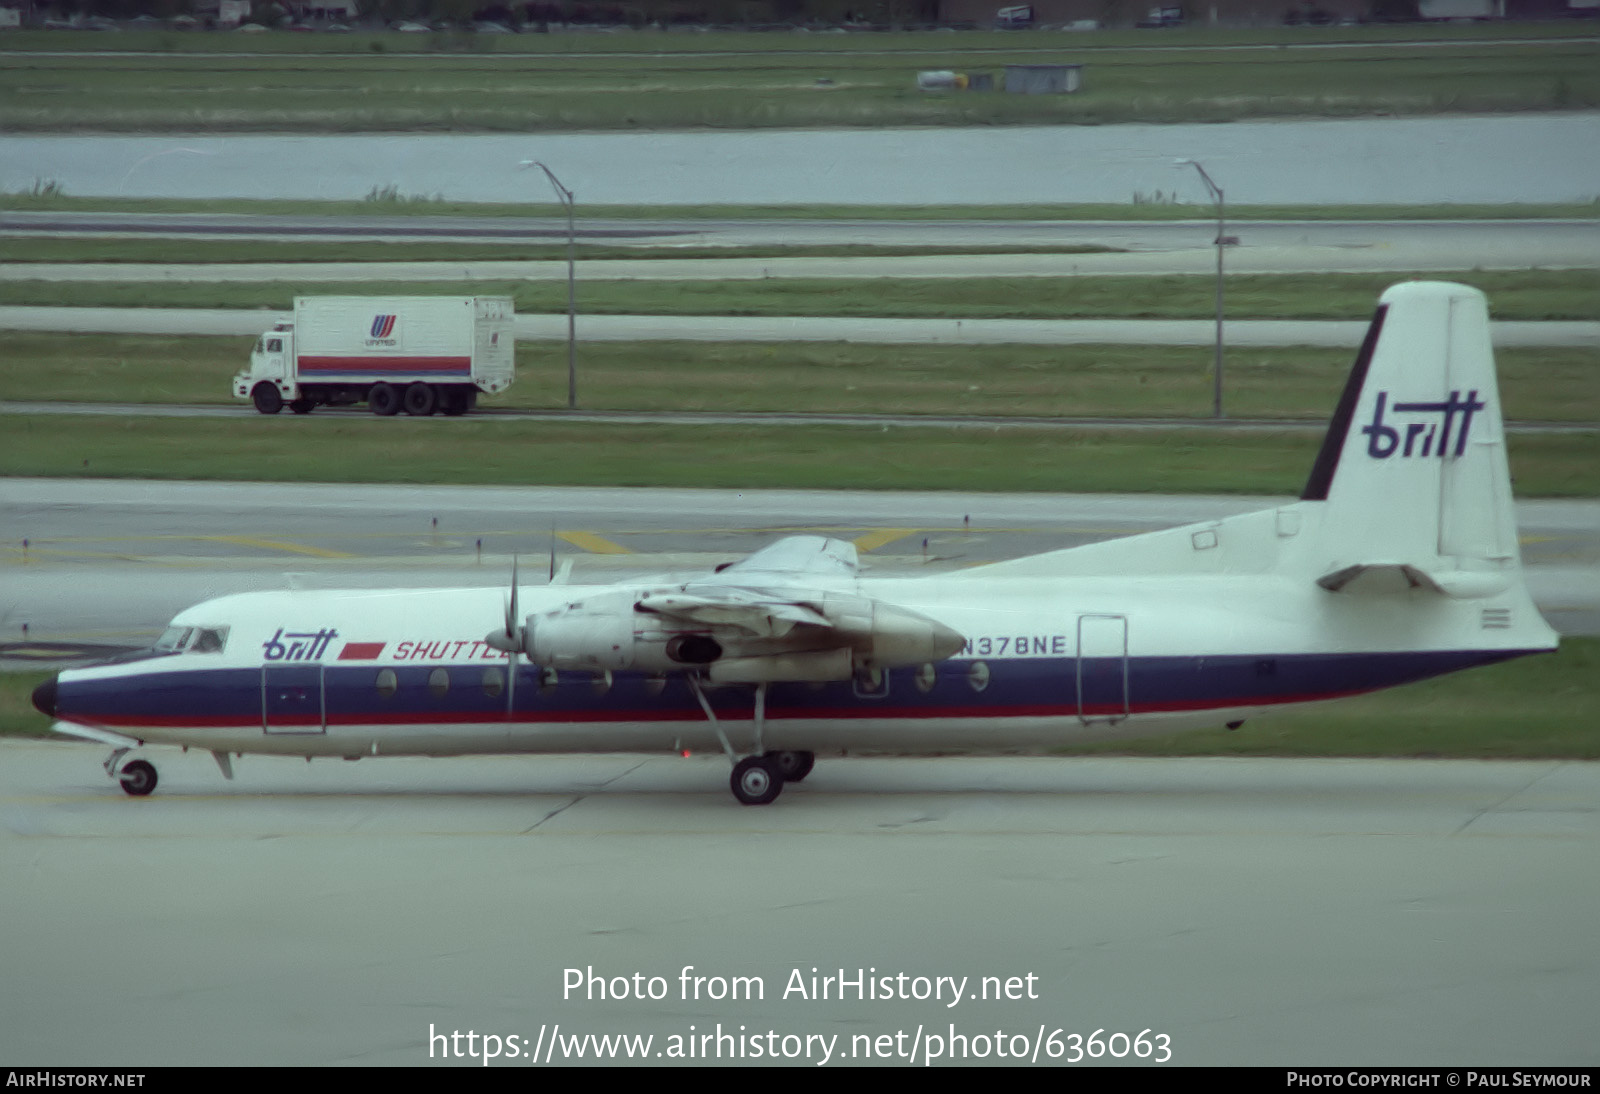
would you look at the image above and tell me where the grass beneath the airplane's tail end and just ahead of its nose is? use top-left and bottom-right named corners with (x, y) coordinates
top-left (0, 638), bottom-right (1600, 760)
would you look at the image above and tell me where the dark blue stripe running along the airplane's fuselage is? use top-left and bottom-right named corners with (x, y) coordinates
top-left (58, 649), bottom-right (1533, 728)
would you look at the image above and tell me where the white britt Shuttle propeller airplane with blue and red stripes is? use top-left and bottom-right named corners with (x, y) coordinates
top-left (34, 281), bottom-right (1558, 805)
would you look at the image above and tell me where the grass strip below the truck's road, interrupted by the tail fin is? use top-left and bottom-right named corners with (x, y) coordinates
top-left (0, 414), bottom-right (1600, 497)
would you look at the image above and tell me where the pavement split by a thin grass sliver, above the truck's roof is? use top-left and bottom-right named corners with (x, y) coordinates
top-left (0, 213), bottom-right (1600, 281)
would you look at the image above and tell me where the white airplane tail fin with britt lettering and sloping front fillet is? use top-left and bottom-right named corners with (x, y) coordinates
top-left (970, 281), bottom-right (1554, 645)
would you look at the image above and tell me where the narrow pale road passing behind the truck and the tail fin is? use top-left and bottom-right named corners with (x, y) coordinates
top-left (0, 305), bottom-right (1600, 345)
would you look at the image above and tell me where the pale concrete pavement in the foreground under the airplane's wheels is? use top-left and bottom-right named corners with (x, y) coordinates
top-left (0, 741), bottom-right (1600, 1067)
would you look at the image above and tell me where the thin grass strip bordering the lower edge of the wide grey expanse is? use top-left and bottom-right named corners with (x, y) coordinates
top-left (0, 193), bottom-right (1600, 220)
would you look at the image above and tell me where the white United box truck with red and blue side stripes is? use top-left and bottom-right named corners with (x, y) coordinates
top-left (234, 296), bottom-right (515, 417)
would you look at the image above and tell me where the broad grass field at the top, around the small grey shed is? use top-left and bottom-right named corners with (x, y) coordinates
top-left (0, 30), bottom-right (1600, 133)
